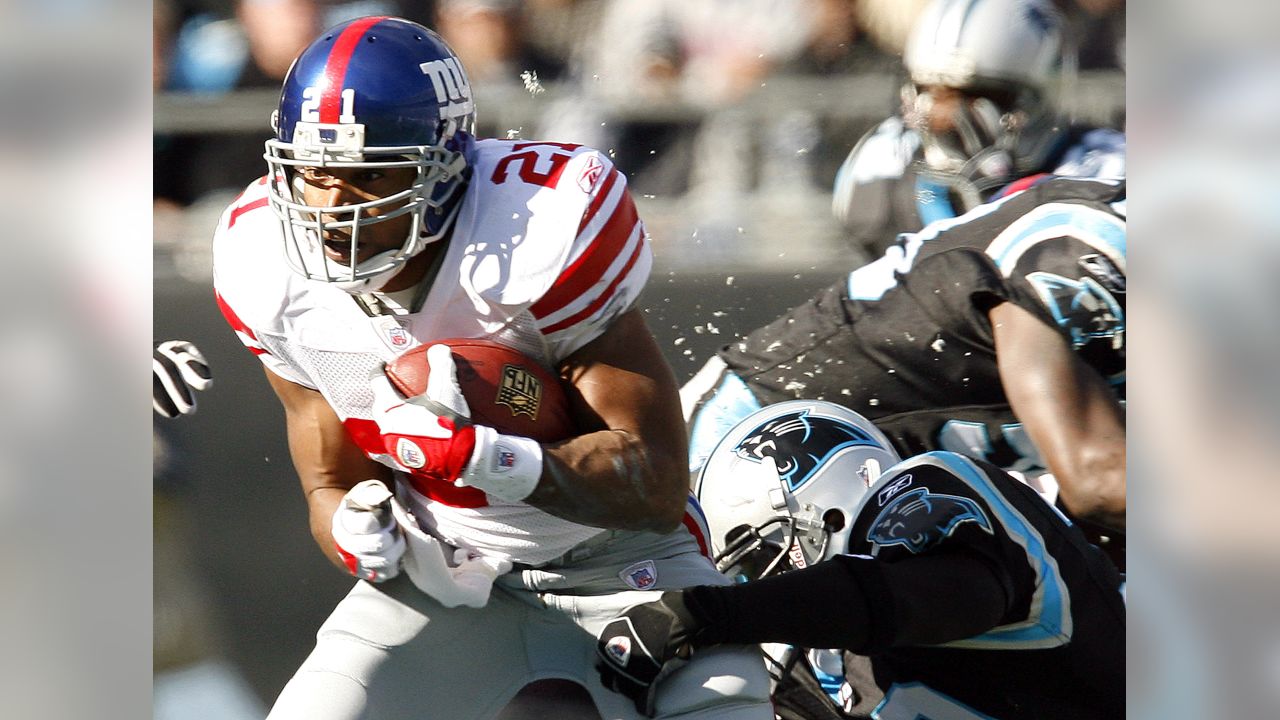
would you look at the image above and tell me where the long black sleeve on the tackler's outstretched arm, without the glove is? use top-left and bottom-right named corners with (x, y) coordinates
top-left (684, 545), bottom-right (1009, 655)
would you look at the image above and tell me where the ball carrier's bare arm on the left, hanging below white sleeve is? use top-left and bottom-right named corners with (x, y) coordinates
top-left (265, 370), bottom-right (390, 570)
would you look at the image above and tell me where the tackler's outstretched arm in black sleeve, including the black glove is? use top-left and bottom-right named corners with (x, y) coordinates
top-left (596, 545), bottom-right (1010, 702)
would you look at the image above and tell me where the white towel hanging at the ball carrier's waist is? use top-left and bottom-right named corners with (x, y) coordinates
top-left (390, 486), bottom-right (511, 607)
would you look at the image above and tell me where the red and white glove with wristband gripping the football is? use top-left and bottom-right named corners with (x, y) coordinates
top-left (370, 345), bottom-right (543, 502)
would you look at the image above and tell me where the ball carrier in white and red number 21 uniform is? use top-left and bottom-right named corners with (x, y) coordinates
top-left (214, 17), bottom-right (772, 720)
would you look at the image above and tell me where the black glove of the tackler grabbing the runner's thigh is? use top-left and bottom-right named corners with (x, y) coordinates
top-left (595, 592), bottom-right (701, 717)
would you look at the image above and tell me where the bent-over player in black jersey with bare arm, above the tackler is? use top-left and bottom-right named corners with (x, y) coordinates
top-left (681, 178), bottom-right (1126, 535)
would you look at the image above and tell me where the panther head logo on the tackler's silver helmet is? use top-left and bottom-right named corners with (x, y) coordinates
top-left (733, 410), bottom-right (883, 492)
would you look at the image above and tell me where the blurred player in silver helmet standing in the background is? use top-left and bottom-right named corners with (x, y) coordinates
top-left (832, 0), bottom-right (1125, 258)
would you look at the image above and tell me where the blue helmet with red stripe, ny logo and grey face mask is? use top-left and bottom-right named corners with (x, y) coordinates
top-left (264, 17), bottom-right (475, 292)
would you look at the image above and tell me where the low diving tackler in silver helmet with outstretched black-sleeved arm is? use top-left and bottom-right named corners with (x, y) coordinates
top-left (598, 401), bottom-right (1125, 720)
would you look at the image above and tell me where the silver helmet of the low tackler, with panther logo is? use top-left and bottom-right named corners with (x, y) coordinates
top-left (694, 400), bottom-right (899, 580)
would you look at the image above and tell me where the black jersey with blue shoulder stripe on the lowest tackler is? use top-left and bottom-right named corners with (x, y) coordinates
top-left (849, 452), bottom-right (1125, 720)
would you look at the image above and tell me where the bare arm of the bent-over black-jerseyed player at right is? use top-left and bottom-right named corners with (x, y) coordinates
top-left (989, 302), bottom-right (1125, 530)
